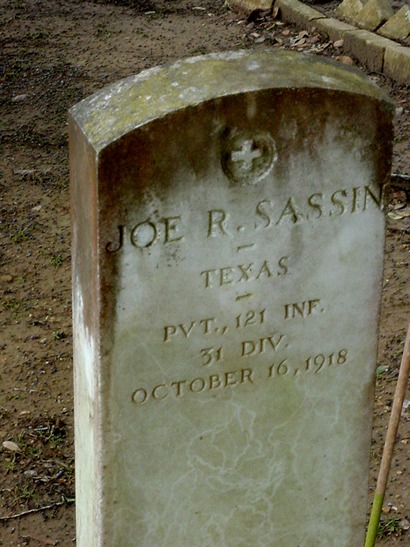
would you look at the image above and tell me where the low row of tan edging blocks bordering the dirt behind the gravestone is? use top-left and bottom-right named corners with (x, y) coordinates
top-left (248, 0), bottom-right (410, 85)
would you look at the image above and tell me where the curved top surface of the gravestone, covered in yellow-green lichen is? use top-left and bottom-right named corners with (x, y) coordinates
top-left (70, 50), bottom-right (394, 152)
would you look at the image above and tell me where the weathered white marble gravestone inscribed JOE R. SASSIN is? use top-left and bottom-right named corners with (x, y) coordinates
top-left (69, 51), bottom-right (393, 547)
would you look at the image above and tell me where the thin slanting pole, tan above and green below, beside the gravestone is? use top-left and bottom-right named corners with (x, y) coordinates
top-left (364, 324), bottom-right (410, 547)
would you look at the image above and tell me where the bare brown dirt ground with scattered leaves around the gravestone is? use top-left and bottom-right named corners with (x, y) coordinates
top-left (0, 0), bottom-right (410, 547)
